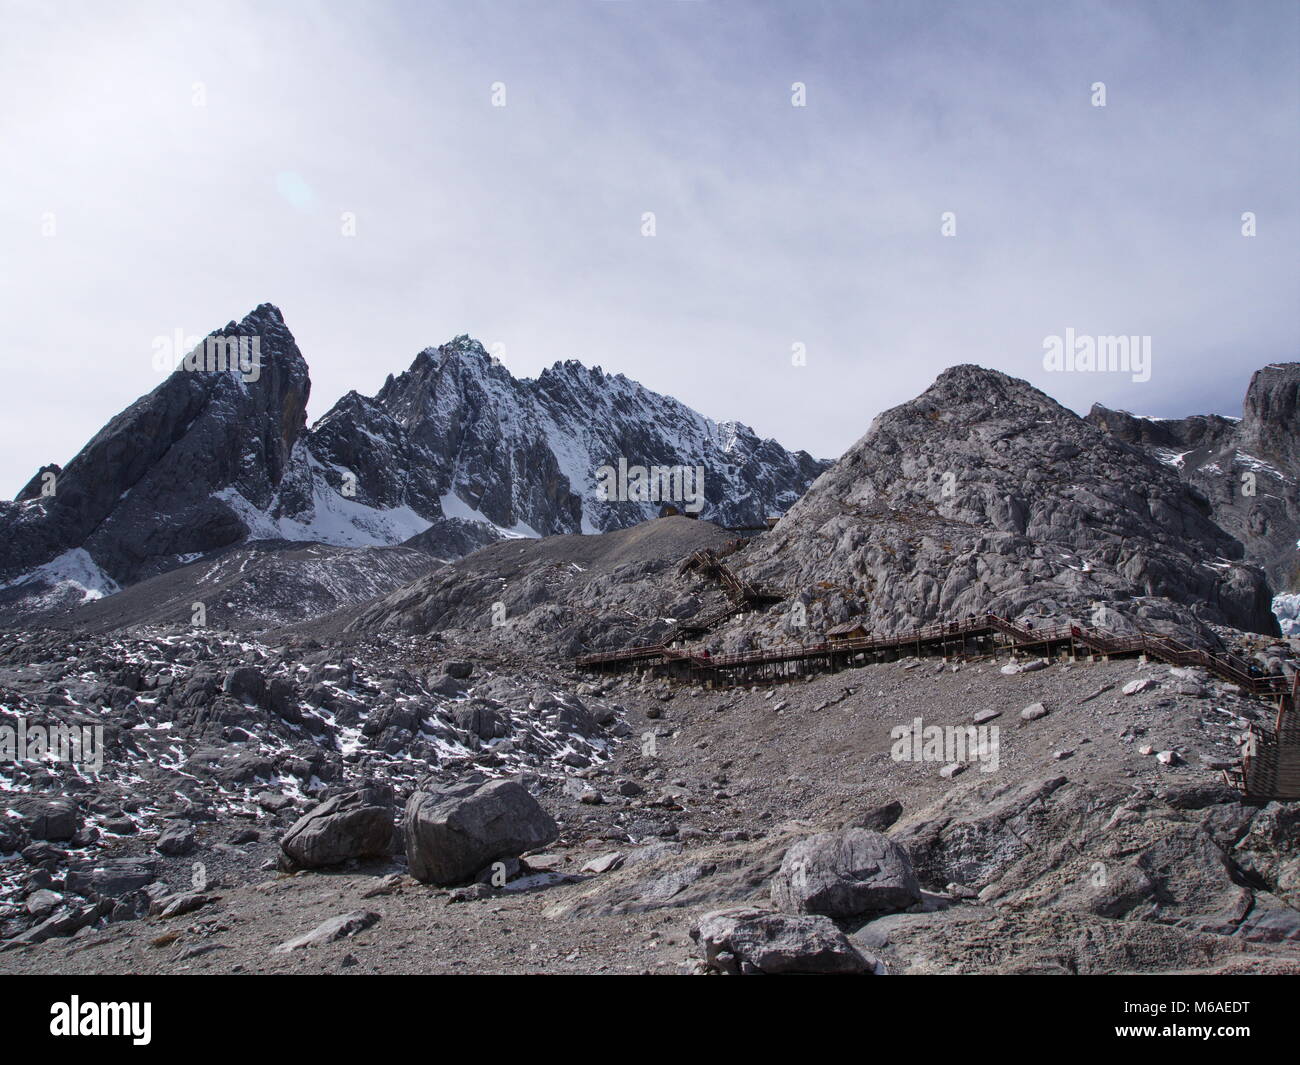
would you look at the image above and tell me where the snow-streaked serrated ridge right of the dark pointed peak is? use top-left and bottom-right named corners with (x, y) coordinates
top-left (322, 337), bottom-right (826, 536)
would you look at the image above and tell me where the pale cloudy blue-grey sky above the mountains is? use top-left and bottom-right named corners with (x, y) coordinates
top-left (0, 0), bottom-right (1300, 495)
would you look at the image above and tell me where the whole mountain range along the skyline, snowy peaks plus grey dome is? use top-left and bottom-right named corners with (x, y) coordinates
top-left (0, 304), bottom-right (1300, 649)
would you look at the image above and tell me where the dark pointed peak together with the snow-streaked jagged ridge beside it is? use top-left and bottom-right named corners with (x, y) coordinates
top-left (0, 304), bottom-right (824, 612)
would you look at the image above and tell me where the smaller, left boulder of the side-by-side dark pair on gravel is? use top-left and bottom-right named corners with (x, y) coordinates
top-left (280, 785), bottom-right (393, 869)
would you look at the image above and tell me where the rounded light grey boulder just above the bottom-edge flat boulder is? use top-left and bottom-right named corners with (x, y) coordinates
top-left (772, 828), bottom-right (920, 917)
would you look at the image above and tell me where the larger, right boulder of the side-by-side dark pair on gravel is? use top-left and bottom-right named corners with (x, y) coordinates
top-left (402, 780), bottom-right (560, 884)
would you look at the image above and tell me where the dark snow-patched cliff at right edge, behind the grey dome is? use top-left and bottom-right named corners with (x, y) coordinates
top-left (1088, 363), bottom-right (1300, 592)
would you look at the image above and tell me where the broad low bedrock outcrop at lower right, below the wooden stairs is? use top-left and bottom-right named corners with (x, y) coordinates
top-left (892, 776), bottom-right (1300, 943)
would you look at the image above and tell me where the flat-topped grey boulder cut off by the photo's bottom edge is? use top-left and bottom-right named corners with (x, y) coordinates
top-left (690, 906), bottom-right (872, 975)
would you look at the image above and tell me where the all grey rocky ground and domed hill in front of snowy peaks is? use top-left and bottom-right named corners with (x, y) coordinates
top-left (0, 352), bottom-right (1300, 975)
